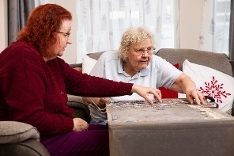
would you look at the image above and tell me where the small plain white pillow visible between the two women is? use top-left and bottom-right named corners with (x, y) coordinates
top-left (82, 55), bottom-right (97, 74)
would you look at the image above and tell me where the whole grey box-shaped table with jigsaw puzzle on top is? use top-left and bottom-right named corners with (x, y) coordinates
top-left (106, 99), bottom-right (234, 156)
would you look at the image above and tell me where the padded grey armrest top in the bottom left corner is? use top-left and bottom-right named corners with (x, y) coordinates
top-left (0, 121), bottom-right (40, 144)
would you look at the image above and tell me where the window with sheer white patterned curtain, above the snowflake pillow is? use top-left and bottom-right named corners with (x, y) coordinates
top-left (199, 0), bottom-right (231, 55)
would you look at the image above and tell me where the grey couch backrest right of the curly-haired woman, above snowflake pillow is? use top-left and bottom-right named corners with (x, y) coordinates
top-left (156, 48), bottom-right (233, 76)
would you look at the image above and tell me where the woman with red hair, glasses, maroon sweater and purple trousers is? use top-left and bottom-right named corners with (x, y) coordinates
top-left (0, 4), bottom-right (165, 156)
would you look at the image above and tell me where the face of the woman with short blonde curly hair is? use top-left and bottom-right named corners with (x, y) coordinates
top-left (125, 39), bottom-right (154, 72)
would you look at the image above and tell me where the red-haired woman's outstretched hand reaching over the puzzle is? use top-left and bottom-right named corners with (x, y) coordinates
top-left (132, 84), bottom-right (162, 104)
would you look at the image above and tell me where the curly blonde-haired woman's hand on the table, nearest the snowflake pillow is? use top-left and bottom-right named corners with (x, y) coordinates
top-left (186, 88), bottom-right (207, 105)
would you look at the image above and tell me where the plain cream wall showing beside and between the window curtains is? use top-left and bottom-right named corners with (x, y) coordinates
top-left (0, 0), bottom-right (204, 63)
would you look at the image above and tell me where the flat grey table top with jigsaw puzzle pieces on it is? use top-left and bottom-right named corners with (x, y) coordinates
top-left (106, 99), bottom-right (234, 125)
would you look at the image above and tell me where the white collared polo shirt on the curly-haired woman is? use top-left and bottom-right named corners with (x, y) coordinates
top-left (90, 51), bottom-right (182, 101)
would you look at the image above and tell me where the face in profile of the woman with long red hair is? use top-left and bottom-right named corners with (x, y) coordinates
top-left (54, 20), bottom-right (72, 56)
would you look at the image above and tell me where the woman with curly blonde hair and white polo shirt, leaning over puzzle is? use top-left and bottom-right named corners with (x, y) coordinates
top-left (83, 27), bottom-right (205, 124)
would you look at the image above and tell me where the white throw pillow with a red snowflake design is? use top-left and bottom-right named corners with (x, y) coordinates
top-left (183, 60), bottom-right (234, 114)
